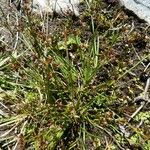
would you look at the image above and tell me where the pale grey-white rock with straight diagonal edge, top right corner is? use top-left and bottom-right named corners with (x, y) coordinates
top-left (119, 0), bottom-right (150, 24)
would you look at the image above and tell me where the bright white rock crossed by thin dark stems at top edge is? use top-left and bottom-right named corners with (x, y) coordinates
top-left (32, 0), bottom-right (79, 16)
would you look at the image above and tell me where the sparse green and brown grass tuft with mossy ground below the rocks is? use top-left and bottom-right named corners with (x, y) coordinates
top-left (0, 1), bottom-right (150, 150)
